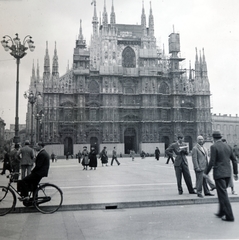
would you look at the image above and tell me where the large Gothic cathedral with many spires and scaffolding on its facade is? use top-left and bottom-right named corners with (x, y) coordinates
top-left (26, 0), bottom-right (212, 155)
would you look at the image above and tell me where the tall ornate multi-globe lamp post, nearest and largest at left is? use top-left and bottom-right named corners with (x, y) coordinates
top-left (1, 33), bottom-right (35, 143)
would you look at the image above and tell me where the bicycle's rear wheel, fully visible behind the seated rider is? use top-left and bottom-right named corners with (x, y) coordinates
top-left (33, 183), bottom-right (63, 213)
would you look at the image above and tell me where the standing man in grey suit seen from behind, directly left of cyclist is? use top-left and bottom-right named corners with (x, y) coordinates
top-left (18, 140), bottom-right (34, 179)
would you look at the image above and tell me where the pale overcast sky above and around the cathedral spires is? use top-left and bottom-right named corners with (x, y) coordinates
top-left (0, 0), bottom-right (239, 129)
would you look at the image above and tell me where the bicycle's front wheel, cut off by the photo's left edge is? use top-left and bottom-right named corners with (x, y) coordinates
top-left (0, 186), bottom-right (17, 216)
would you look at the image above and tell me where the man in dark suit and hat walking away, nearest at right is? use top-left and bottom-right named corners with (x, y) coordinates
top-left (206, 131), bottom-right (238, 222)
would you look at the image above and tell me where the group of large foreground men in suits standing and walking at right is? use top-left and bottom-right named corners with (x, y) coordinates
top-left (166, 131), bottom-right (239, 221)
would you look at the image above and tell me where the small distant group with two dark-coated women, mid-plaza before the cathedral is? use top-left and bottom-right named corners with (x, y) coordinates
top-left (78, 146), bottom-right (120, 170)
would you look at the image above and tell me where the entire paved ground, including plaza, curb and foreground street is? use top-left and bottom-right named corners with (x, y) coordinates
top-left (0, 157), bottom-right (239, 240)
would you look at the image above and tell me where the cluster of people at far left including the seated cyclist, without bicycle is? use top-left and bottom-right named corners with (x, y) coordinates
top-left (1, 140), bottom-right (50, 201)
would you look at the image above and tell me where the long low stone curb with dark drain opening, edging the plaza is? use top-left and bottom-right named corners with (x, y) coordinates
top-left (11, 197), bottom-right (239, 213)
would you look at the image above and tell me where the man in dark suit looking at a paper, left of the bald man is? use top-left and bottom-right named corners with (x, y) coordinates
top-left (166, 135), bottom-right (196, 195)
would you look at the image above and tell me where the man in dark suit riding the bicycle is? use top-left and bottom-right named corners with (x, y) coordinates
top-left (17, 142), bottom-right (50, 201)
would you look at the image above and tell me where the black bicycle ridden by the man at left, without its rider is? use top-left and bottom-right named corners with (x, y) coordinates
top-left (0, 173), bottom-right (63, 216)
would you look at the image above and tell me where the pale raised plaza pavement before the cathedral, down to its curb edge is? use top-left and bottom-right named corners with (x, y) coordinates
top-left (0, 156), bottom-right (239, 212)
